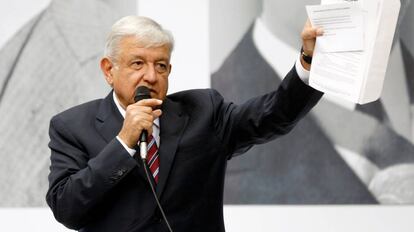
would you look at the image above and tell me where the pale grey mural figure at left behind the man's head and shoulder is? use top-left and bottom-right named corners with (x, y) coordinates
top-left (0, 0), bottom-right (135, 207)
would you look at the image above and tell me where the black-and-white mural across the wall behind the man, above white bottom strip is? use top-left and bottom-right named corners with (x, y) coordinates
top-left (0, 0), bottom-right (414, 210)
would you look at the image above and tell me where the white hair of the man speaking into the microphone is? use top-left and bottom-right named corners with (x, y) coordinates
top-left (104, 16), bottom-right (174, 62)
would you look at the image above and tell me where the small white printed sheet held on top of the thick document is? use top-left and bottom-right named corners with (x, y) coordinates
top-left (306, 3), bottom-right (364, 52)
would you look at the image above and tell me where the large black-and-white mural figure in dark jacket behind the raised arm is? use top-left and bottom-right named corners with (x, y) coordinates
top-left (212, 0), bottom-right (414, 204)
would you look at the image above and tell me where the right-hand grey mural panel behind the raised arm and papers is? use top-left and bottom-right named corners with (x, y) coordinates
top-left (210, 0), bottom-right (414, 204)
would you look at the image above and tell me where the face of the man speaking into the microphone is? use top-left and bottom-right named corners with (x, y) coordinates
top-left (104, 36), bottom-right (171, 108)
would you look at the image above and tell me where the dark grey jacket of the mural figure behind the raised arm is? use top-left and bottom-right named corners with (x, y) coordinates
top-left (211, 24), bottom-right (377, 204)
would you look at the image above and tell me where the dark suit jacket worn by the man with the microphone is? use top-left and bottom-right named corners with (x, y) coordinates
top-left (46, 70), bottom-right (322, 232)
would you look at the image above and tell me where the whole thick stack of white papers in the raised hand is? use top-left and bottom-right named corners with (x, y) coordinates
top-left (306, 0), bottom-right (400, 104)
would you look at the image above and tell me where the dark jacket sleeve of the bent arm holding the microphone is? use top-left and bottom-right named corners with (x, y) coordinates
top-left (46, 115), bottom-right (137, 229)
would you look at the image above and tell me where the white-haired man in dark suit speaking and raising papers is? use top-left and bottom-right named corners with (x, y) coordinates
top-left (46, 16), bottom-right (322, 231)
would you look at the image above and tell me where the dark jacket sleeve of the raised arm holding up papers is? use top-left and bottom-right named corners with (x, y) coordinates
top-left (211, 65), bottom-right (322, 158)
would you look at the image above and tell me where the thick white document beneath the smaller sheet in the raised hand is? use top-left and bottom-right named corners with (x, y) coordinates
top-left (309, 0), bottom-right (401, 104)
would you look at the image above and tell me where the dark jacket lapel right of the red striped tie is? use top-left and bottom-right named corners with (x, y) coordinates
top-left (157, 98), bottom-right (188, 198)
